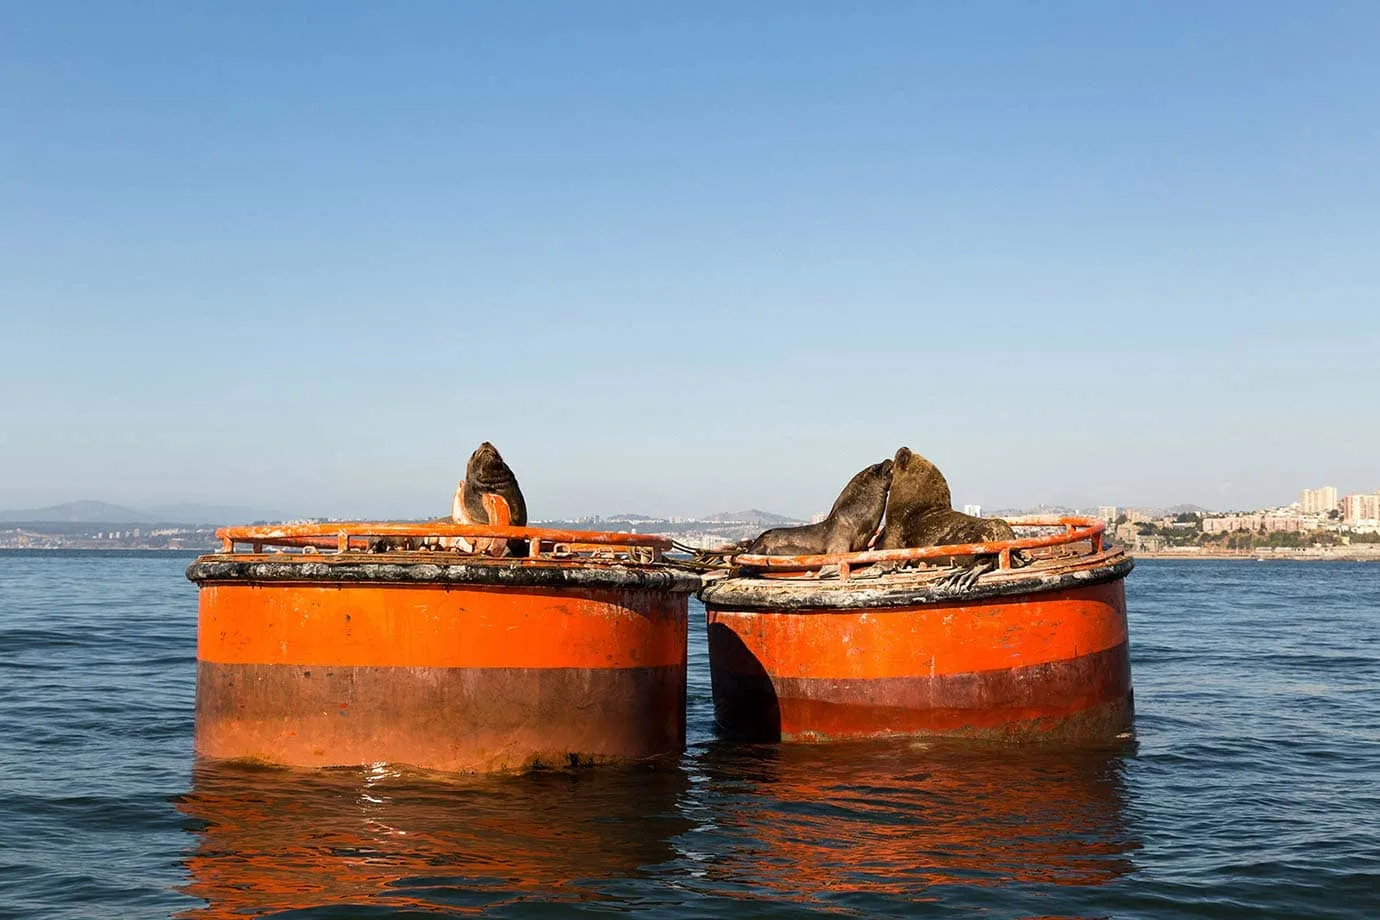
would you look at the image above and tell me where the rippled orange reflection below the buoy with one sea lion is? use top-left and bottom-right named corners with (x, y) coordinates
top-left (178, 763), bottom-right (689, 919)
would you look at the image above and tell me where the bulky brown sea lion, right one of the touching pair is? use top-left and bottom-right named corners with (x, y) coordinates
top-left (880, 447), bottom-right (1016, 586)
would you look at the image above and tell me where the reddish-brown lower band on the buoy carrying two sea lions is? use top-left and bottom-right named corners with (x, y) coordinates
top-left (711, 645), bottom-right (1134, 742)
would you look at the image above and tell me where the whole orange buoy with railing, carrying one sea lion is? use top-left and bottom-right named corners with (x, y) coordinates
top-left (186, 523), bottom-right (700, 771)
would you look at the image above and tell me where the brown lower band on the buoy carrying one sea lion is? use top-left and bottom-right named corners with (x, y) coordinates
top-left (196, 661), bottom-right (686, 772)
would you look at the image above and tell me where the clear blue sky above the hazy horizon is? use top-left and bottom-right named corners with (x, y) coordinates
top-left (0, 3), bottom-right (1380, 517)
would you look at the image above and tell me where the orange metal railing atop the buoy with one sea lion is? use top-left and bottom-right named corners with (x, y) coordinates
top-left (215, 521), bottom-right (671, 563)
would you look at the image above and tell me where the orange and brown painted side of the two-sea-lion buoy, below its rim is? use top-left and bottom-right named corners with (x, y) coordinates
top-left (707, 577), bottom-right (1133, 742)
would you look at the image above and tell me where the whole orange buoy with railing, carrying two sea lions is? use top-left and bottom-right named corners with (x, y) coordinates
top-left (701, 517), bottom-right (1134, 742)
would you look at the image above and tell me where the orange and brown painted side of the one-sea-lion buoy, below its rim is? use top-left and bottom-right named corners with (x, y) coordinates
top-left (189, 579), bottom-right (689, 772)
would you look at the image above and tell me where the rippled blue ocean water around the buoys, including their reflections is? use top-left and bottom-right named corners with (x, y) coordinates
top-left (0, 553), bottom-right (1380, 920)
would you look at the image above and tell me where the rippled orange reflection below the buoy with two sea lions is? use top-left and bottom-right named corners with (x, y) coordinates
top-left (686, 742), bottom-right (1140, 902)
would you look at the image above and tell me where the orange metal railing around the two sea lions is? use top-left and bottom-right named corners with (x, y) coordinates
top-left (733, 516), bottom-right (1107, 579)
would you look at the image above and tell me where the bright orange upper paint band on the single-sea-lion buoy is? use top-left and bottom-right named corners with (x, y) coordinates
top-left (197, 585), bottom-right (686, 668)
